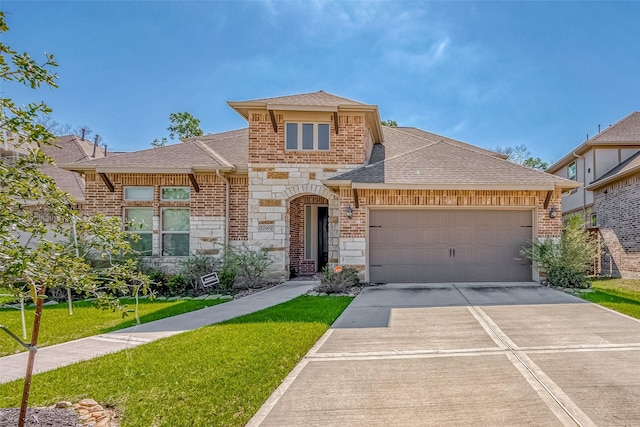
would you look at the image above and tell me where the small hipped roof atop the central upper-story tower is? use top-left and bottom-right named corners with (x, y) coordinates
top-left (227, 90), bottom-right (383, 142)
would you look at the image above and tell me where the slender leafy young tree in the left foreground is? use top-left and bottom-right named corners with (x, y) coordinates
top-left (0, 12), bottom-right (148, 426)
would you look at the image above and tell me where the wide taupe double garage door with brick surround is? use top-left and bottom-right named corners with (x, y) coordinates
top-left (369, 209), bottom-right (532, 283)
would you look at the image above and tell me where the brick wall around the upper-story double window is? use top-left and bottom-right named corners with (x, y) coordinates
top-left (249, 111), bottom-right (367, 165)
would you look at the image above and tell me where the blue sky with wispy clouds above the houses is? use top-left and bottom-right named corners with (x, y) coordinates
top-left (0, 0), bottom-right (640, 166)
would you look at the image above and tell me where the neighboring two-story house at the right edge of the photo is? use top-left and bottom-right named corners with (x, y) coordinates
top-left (547, 112), bottom-right (640, 277)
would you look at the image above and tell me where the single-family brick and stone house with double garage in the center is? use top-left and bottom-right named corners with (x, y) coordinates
top-left (64, 91), bottom-right (578, 282)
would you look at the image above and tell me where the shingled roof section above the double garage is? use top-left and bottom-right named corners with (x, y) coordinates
top-left (325, 127), bottom-right (580, 190)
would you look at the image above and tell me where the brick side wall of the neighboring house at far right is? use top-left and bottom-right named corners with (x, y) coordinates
top-left (593, 175), bottom-right (640, 278)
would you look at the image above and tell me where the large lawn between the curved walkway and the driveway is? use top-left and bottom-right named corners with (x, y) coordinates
top-left (0, 296), bottom-right (352, 427)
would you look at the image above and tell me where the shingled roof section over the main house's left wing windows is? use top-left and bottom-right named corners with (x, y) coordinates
top-left (64, 129), bottom-right (249, 173)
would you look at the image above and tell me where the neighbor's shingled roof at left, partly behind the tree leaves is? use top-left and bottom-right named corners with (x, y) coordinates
top-left (39, 135), bottom-right (105, 203)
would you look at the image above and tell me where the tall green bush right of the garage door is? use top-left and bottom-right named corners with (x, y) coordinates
top-left (521, 215), bottom-right (598, 288)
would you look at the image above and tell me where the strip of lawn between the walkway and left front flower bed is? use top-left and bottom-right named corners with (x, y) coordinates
top-left (0, 299), bottom-right (223, 356)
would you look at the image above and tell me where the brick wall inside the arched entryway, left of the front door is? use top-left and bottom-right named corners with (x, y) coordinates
top-left (289, 195), bottom-right (329, 275)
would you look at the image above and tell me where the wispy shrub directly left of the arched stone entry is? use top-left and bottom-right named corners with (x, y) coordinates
top-left (225, 246), bottom-right (271, 289)
